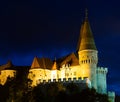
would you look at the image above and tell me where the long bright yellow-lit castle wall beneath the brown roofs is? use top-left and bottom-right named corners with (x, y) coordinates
top-left (28, 65), bottom-right (90, 86)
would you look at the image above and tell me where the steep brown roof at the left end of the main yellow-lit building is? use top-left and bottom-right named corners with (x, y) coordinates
top-left (31, 57), bottom-right (53, 69)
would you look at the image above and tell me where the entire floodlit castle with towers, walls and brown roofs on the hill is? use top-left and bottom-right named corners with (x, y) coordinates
top-left (0, 13), bottom-right (115, 102)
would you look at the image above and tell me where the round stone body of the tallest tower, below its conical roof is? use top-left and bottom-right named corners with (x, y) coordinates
top-left (79, 50), bottom-right (98, 89)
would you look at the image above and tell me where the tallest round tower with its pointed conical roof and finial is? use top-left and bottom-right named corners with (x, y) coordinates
top-left (77, 11), bottom-right (98, 89)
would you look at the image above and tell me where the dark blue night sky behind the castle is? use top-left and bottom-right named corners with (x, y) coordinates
top-left (0, 0), bottom-right (120, 95)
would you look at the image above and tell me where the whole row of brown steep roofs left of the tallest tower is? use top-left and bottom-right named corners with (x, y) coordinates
top-left (31, 53), bottom-right (79, 70)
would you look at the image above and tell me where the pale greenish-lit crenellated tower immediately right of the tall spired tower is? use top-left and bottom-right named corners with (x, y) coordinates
top-left (96, 67), bottom-right (108, 94)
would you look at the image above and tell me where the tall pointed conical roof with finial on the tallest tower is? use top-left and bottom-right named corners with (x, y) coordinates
top-left (77, 9), bottom-right (97, 51)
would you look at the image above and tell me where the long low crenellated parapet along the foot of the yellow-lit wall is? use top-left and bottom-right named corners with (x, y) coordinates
top-left (37, 77), bottom-right (91, 87)
